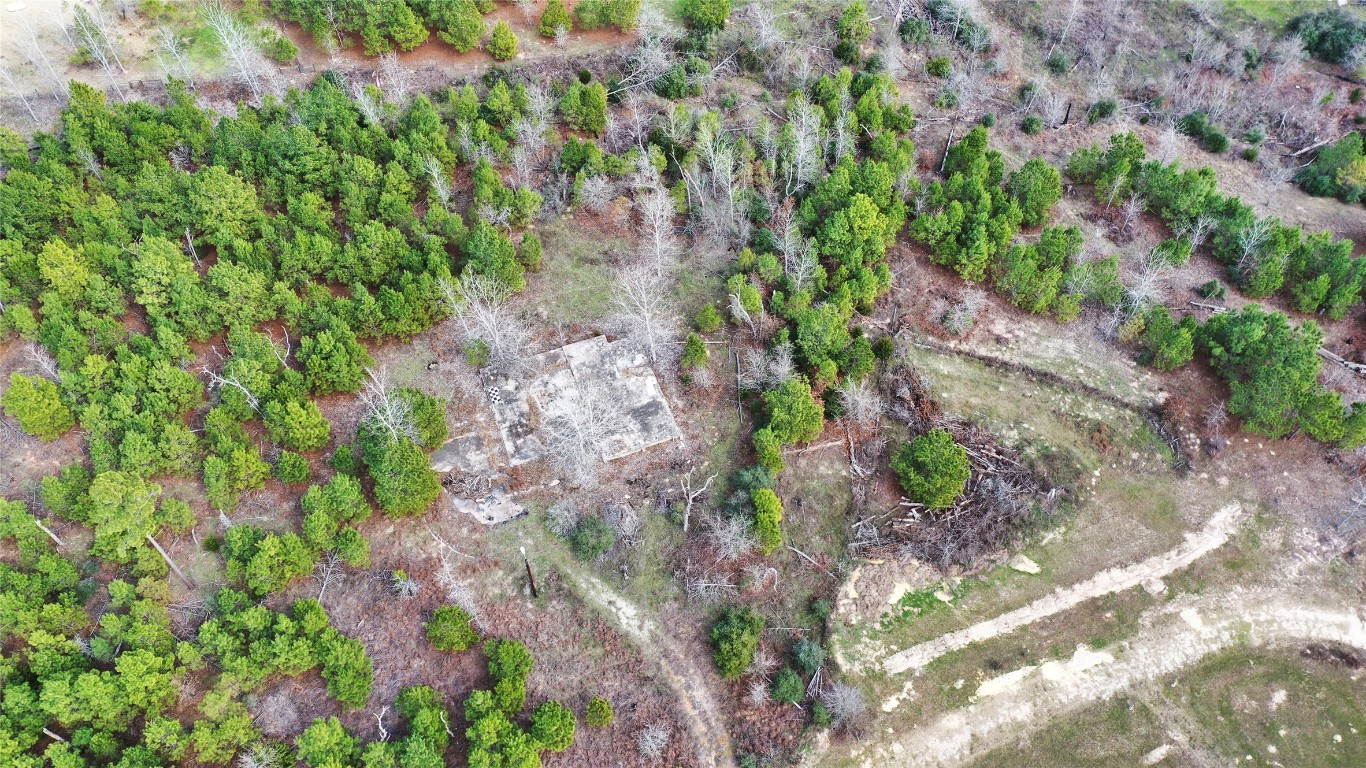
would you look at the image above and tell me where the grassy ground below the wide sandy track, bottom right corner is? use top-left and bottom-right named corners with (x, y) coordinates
top-left (974, 650), bottom-right (1366, 768)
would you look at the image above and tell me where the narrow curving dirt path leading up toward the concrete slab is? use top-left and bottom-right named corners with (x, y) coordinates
top-left (560, 568), bottom-right (735, 768)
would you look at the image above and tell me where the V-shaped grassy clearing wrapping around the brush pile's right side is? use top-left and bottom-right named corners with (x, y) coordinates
top-left (840, 340), bottom-right (1213, 664)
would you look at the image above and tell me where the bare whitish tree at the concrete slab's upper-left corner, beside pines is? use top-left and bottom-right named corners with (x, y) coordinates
top-left (441, 273), bottom-right (531, 374)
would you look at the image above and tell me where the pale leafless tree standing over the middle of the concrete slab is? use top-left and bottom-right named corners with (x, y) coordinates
top-left (541, 389), bottom-right (623, 485)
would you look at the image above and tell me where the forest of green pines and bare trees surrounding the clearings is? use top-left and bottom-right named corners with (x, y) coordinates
top-left (0, 0), bottom-right (1366, 768)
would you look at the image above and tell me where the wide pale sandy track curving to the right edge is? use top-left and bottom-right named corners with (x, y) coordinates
top-left (862, 590), bottom-right (1366, 768)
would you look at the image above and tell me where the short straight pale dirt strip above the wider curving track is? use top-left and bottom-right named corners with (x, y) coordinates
top-left (882, 503), bottom-right (1242, 675)
